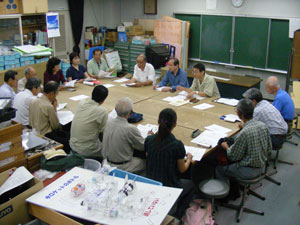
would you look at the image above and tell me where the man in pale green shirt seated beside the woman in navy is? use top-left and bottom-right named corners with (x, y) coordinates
top-left (87, 48), bottom-right (109, 78)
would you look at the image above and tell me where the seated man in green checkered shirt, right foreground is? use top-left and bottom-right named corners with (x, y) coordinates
top-left (216, 99), bottom-right (272, 179)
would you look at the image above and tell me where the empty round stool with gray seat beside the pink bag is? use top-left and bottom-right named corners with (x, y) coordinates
top-left (199, 179), bottom-right (229, 213)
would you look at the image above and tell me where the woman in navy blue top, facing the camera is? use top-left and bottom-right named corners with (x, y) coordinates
top-left (67, 52), bottom-right (89, 82)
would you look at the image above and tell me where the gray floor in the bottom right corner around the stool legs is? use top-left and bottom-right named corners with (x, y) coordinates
top-left (215, 132), bottom-right (300, 225)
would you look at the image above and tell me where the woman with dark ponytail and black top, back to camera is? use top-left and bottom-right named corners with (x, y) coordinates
top-left (145, 109), bottom-right (194, 219)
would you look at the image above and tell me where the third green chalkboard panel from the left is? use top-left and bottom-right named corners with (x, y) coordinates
top-left (233, 17), bottom-right (269, 68)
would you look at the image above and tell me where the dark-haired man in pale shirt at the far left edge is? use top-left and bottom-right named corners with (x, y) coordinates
top-left (0, 70), bottom-right (18, 105)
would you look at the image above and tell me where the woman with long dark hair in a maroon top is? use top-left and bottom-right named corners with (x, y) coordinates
top-left (44, 57), bottom-right (66, 89)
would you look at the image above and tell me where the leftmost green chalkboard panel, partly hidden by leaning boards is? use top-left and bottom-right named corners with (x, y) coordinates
top-left (175, 14), bottom-right (201, 58)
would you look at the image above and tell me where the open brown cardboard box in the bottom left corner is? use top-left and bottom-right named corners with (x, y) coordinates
top-left (0, 170), bottom-right (43, 225)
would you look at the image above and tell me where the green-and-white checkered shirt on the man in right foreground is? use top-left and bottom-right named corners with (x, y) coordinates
top-left (227, 120), bottom-right (272, 168)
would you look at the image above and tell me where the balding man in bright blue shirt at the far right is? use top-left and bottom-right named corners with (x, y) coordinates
top-left (266, 76), bottom-right (295, 133)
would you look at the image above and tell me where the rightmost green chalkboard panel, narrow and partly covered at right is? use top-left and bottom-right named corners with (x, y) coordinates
top-left (268, 19), bottom-right (292, 70)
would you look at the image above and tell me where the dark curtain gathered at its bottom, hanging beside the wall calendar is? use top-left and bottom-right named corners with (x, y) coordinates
top-left (68, 0), bottom-right (84, 54)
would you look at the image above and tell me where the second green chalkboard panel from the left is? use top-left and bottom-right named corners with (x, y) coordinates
top-left (200, 15), bottom-right (232, 63)
